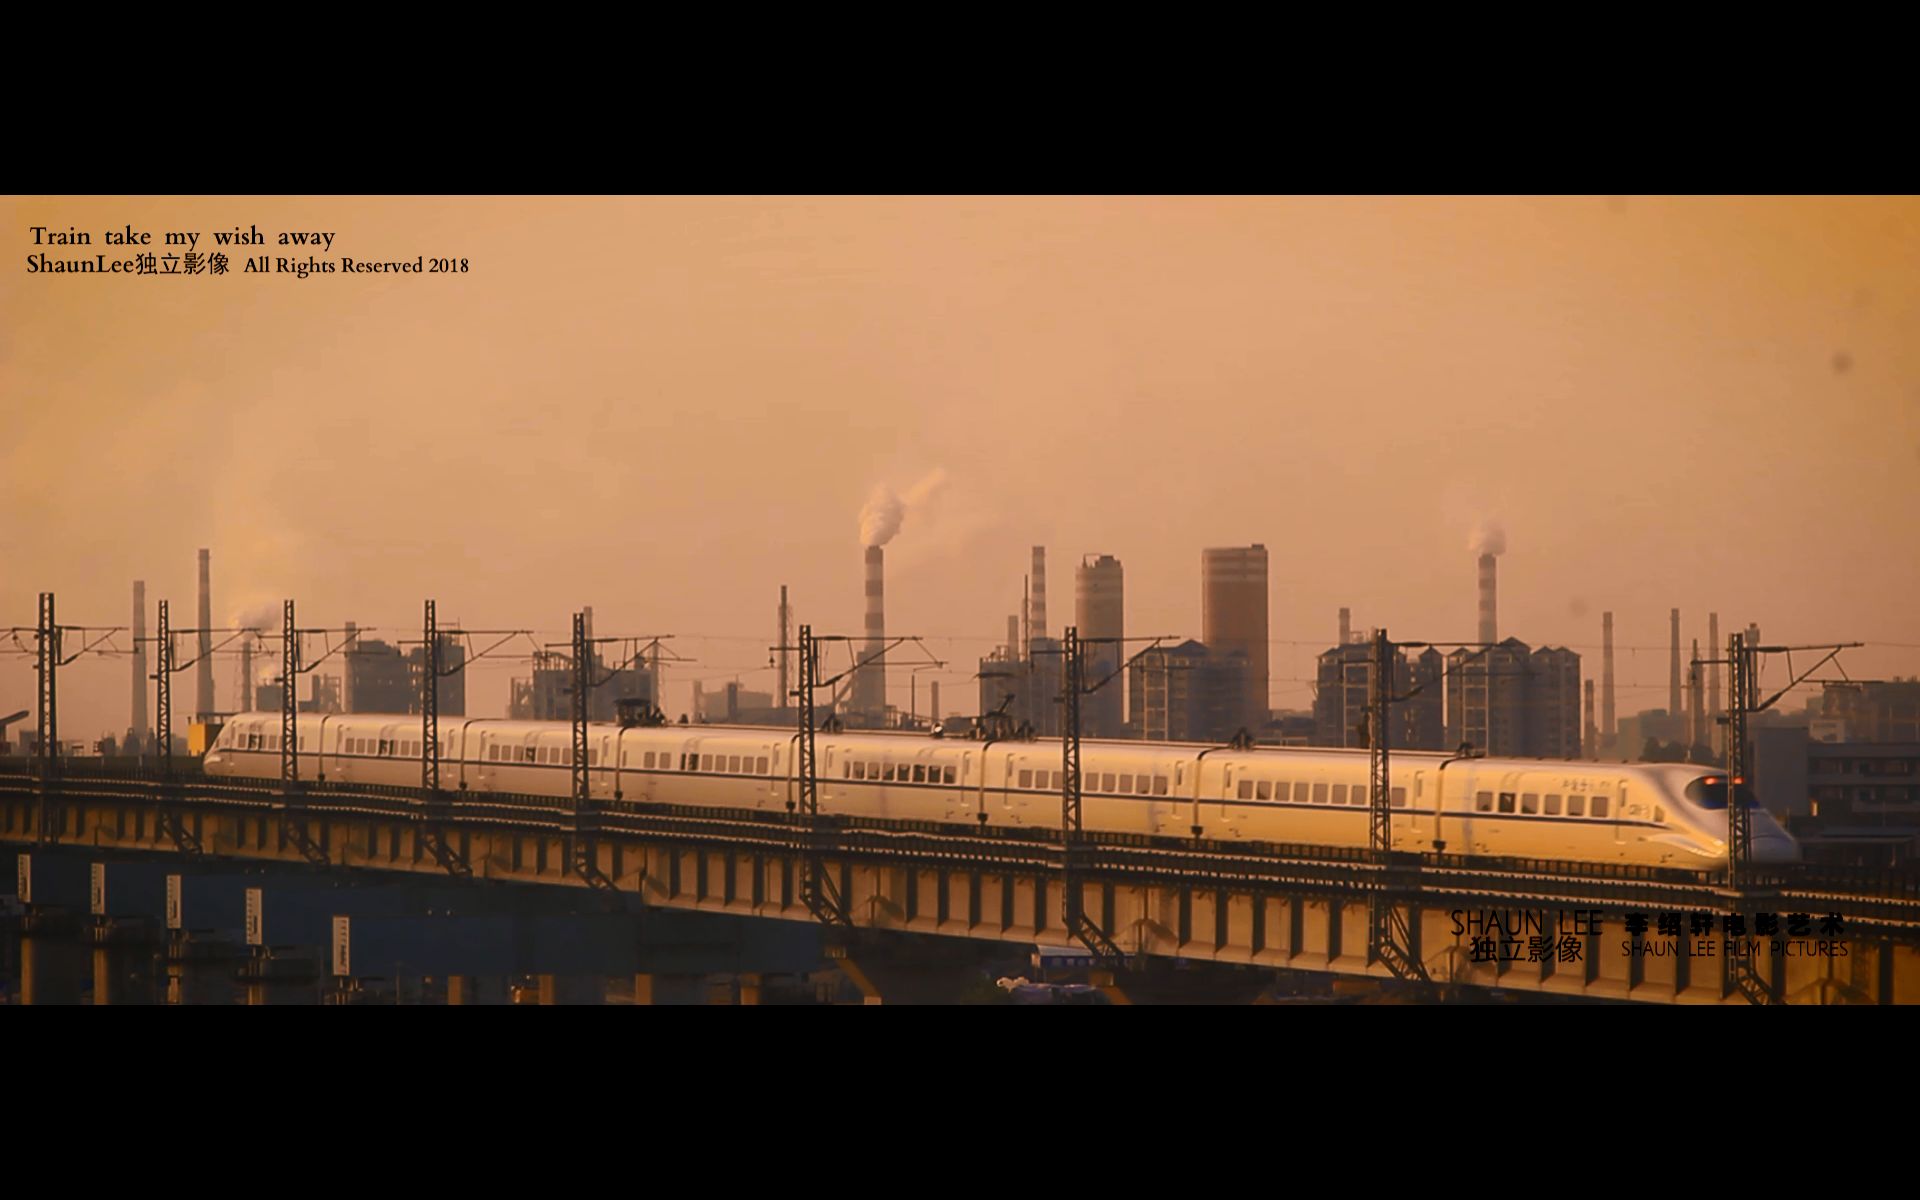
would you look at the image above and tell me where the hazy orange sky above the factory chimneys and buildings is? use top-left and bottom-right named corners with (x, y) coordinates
top-left (0, 196), bottom-right (1920, 737)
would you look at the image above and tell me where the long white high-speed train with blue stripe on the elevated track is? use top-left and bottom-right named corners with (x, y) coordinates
top-left (204, 712), bottom-right (1799, 872)
